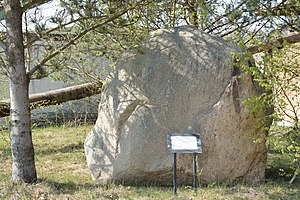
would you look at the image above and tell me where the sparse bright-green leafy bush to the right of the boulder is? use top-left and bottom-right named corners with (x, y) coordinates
top-left (244, 40), bottom-right (300, 182)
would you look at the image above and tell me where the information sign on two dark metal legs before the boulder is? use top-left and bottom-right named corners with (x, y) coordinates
top-left (168, 133), bottom-right (202, 194)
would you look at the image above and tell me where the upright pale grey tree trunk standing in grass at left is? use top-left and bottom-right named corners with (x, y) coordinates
top-left (4, 0), bottom-right (37, 182)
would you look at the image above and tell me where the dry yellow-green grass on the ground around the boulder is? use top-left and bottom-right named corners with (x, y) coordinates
top-left (0, 125), bottom-right (300, 200)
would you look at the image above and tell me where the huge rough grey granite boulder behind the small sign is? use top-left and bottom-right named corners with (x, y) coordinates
top-left (85, 26), bottom-right (266, 185)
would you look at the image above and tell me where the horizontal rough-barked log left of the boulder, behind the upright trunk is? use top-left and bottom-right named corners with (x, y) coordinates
top-left (0, 82), bottom-right (102, 117)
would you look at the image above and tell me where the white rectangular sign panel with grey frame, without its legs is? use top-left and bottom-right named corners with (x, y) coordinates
top-left (168, 133), bottom-right (202, 153)
